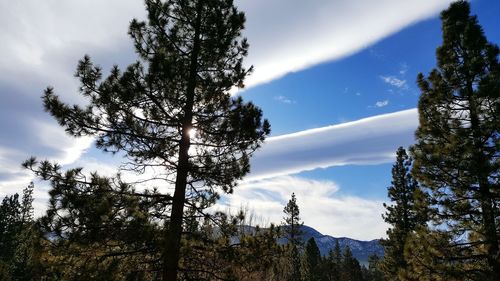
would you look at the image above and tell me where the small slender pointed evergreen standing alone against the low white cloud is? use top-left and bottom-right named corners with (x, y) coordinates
top-left (283, 193), bottom-right (304, 281)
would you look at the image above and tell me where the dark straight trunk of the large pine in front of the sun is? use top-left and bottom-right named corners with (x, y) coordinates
top-left (163, 1), bottom-right (203, 281)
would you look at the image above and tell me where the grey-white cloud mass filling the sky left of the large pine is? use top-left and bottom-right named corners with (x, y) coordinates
top-left (0, 0), bottom-right (144, 194)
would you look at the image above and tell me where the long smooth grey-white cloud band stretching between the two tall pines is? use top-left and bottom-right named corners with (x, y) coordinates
top-left (247, 109), bottom-right (418, 180)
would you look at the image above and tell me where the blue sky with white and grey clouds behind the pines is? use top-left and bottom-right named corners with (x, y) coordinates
top-left (0, 0), bottom-right (500, 240)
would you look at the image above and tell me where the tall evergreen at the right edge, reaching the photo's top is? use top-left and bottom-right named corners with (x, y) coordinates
top-left (412, 1), bottom-right (500, 280)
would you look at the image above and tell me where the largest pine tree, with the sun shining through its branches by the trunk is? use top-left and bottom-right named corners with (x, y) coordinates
top-left (25, 0), bottom-right (270, 280)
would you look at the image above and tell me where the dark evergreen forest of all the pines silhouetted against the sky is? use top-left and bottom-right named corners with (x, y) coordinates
top-left (0, 0), bottom-right (500, 281)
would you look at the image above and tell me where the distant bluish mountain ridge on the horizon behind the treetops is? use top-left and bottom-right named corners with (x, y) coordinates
top-left (278, 225), bottom-right (384, 265)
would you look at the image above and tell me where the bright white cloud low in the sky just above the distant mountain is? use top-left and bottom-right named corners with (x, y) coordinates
top-left (218, 176), bottom-right (387, 240)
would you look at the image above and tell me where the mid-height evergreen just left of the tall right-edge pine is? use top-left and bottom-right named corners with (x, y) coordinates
top-left (380, 147), bottom-right (427, 280)
